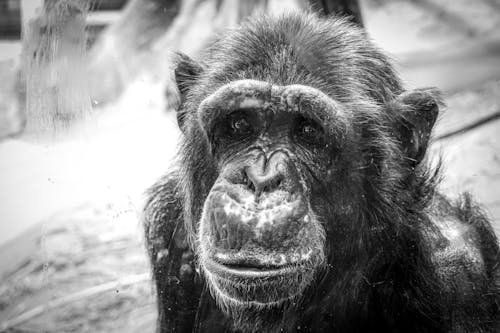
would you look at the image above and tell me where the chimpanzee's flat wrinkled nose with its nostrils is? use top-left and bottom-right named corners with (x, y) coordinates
top-left (245, 153), bottom-right (287, 195)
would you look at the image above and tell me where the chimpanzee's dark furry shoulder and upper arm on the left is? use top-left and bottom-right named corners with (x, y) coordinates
top-left (142, 172), bottom-right (202, 332)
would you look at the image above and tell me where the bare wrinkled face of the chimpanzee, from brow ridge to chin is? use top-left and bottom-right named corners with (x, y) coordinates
top-left (198, 80), bottom-right (356, 305)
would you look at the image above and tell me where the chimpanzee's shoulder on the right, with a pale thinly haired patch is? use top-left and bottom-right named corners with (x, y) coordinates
top-left (422, 193), bottom-right (500, 332)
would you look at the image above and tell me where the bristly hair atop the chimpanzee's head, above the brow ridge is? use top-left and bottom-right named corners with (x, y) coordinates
top-left (200, 15), bottom-right (400, 103)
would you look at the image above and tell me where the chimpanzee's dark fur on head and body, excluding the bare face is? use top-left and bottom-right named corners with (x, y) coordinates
top-left (144, 15), bottom-right (500, 332)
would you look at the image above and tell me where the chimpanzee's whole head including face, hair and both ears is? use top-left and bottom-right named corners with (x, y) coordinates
top-left (175, 15), bottom-right (438, 330)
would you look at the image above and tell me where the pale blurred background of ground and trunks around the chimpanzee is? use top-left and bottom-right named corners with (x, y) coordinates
top-left (0, 0), bottom-right (500, 332)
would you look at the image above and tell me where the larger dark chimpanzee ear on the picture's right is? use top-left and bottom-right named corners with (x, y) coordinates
top-left (390, 88), bottom-right (443, 165)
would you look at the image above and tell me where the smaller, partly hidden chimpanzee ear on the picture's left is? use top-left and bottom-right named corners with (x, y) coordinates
top-left (173, 52), bottom-right (203, 129)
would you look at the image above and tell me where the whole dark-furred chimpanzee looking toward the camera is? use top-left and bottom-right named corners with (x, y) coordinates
top-left (144, 13), bottom-right (500, 332)
